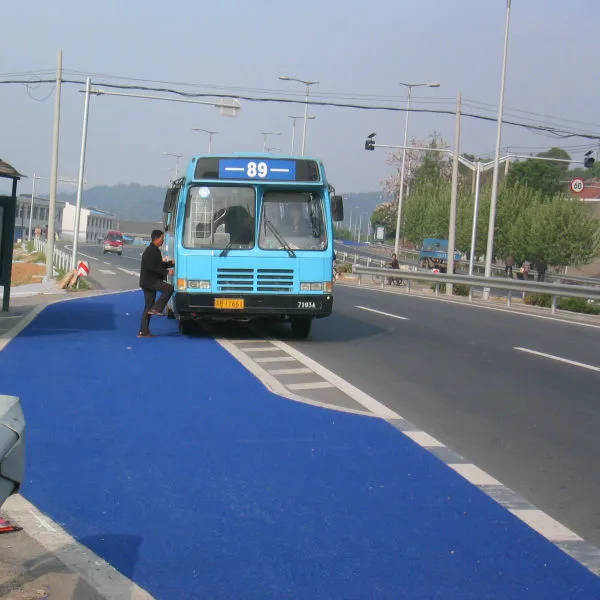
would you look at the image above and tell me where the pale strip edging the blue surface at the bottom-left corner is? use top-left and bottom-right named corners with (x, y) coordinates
top-left (2, 494), bottom-right (153, 600)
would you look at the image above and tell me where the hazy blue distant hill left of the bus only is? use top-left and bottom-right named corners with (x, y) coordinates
top-left (58, 183), bottom-right (167, 222)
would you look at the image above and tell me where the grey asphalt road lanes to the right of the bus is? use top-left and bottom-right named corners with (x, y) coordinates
top-left (284, 286), bottom-right (600, 546)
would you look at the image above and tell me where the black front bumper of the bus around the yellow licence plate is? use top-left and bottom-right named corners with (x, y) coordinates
top-left (173, 292), bottom-right (333, 320)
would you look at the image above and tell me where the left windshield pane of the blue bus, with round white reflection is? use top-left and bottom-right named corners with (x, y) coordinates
top-left (183, 186), bottom-right (256, 250)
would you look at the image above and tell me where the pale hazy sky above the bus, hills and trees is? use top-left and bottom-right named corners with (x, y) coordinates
top-left (0, 0), bottom-right (600, 199)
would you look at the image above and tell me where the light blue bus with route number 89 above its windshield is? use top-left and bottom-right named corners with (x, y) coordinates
top-left (163, 153), bottom-right (344, 338)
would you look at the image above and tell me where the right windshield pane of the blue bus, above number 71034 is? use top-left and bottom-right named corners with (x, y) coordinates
top-left (258, 191), bottom-right (327, 250)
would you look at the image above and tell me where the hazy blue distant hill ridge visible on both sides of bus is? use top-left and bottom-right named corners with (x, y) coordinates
top-left (58, 183), bottom-right (389, 225)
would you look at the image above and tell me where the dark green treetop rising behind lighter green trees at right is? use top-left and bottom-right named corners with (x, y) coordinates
top-left (507, 148), bottom-right (571, 196)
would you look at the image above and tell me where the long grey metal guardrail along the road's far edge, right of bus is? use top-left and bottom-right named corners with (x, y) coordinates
top-left (352, 266), bottom-right (600, 313)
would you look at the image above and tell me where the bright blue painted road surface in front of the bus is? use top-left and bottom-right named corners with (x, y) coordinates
top-left (0, 292), bottom-right (600, 600)
